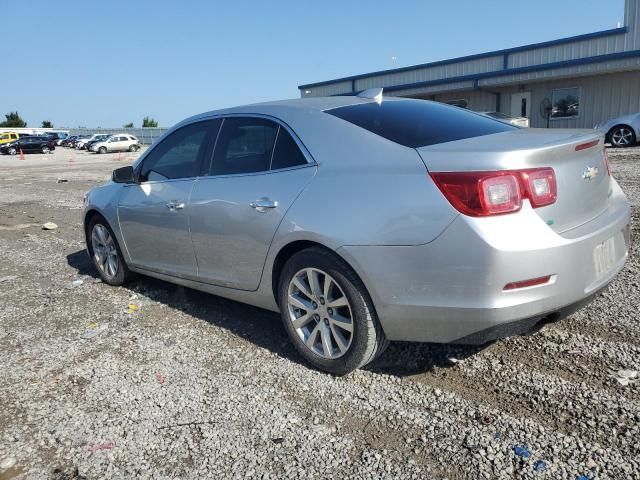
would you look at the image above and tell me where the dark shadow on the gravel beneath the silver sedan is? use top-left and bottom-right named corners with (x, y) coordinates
top-left (67, 250), bottom-right (486, 376)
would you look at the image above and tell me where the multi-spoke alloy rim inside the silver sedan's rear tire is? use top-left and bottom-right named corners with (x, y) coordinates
top-left (287, 268), bottom-right (353, 359)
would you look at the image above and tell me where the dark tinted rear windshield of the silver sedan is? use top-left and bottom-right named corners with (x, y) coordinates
top-left (326, 100), bottom-right (517, 148)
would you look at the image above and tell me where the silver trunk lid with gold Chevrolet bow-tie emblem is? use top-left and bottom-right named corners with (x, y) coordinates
top-left (417, 129), bottom-right (611, 233)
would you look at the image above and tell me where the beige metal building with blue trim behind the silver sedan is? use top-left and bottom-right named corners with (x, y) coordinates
top-left (298, 0), bottom-right (640, 128)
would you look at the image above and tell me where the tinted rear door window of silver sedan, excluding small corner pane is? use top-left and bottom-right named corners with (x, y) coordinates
top-left (209, 117), bottom-right (278, 175)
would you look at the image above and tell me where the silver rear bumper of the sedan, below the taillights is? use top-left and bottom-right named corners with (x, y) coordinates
top-left (338, 182), bottom-right (630, 343)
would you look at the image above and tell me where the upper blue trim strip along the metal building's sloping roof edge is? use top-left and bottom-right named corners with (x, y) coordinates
top-left (298, 27), bottom-right (629, 90)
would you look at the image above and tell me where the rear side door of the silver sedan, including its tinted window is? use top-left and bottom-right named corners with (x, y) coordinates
top-left (189, 117), bottom-right (316, 290)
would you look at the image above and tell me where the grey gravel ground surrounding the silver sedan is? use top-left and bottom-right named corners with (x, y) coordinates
top-left (0, 148), bottom-right (640, 480)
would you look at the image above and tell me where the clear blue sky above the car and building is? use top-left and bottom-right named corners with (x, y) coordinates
top-left (0, 0), bottom-right (624, 127)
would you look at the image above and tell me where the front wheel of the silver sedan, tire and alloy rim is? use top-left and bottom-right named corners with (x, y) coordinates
top-left (87, 215), bottom-right (131, 286)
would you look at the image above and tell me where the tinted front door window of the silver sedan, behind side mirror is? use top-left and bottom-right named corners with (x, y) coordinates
top-left (139, 122), bottom-right (212, 182)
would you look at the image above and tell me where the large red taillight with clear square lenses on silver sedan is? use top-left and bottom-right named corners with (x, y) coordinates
top-left (430, 167), bottom-right (557, 217)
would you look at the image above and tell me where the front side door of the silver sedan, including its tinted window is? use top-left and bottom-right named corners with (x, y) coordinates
top-left (118, 121), bottom-right (221, 277)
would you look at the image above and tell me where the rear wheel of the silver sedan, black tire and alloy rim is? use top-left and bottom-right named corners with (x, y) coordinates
top-left (278, 247), bottom-right (388, 376)
